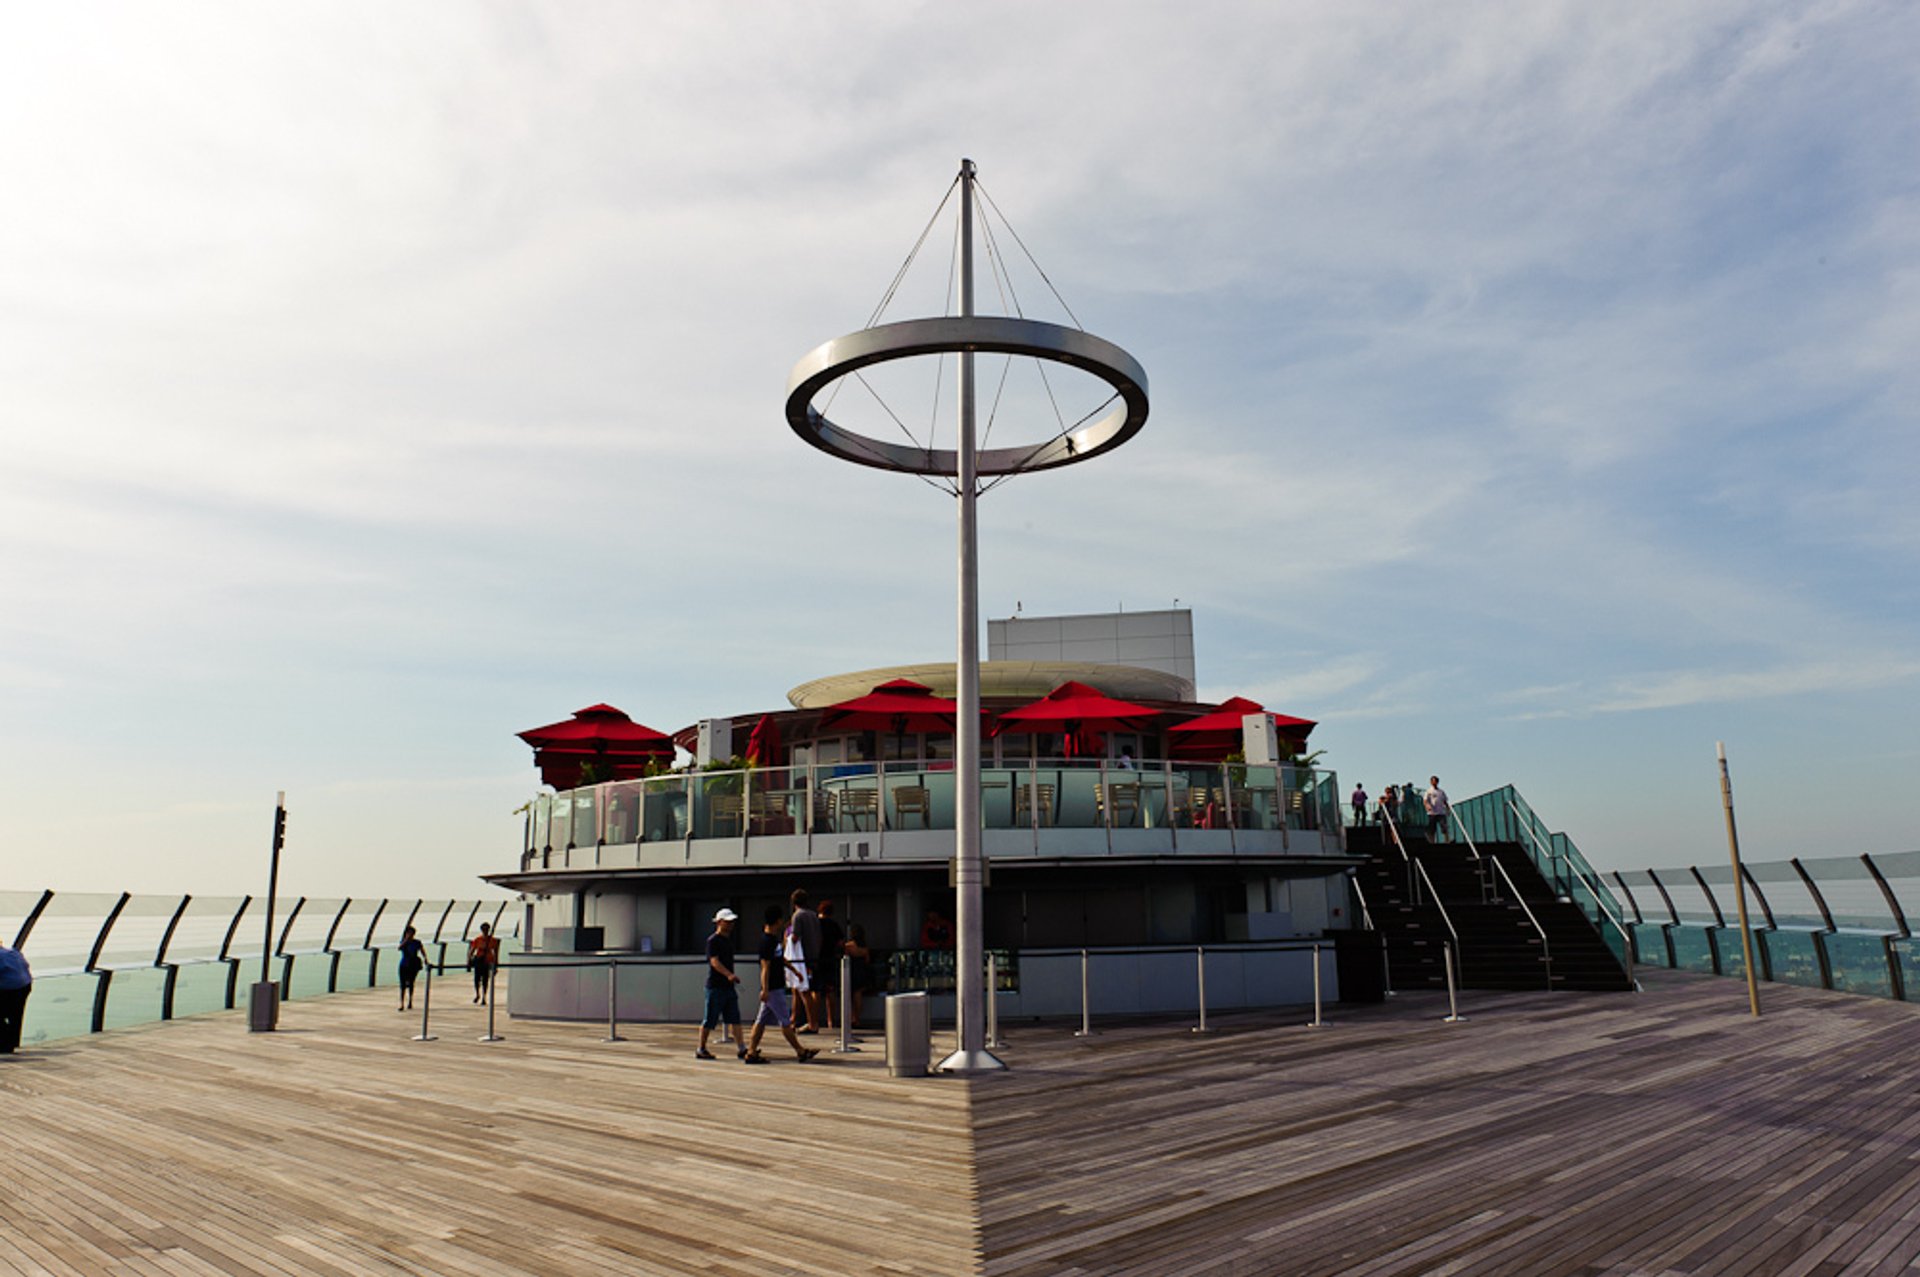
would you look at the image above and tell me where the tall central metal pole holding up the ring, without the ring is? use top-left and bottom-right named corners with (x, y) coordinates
top-left (941, 159), bottom-right (1006, 1073)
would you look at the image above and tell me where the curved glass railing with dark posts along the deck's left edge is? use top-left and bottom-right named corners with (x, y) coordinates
top-left (0, 891), bottom-right (520, 1045)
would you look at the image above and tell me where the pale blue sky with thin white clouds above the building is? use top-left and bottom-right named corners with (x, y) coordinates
top-left (0, 0), bottom-right (1920, 897)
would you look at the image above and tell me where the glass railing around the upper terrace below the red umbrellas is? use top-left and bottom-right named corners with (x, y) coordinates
top-left (522, 759), bottom-right (1340, 868)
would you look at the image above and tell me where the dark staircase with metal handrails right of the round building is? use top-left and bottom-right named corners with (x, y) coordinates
top-left (1348, 826), bottom-right (1632, 991)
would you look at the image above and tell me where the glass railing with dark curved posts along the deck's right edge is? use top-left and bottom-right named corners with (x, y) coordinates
top-left (1607, 851), bottom-right (1920, 1000)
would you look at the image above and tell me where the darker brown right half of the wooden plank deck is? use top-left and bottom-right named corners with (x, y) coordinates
top-left (973, 972), bottom-right (1920, 1277)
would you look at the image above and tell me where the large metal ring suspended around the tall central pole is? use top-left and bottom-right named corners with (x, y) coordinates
top-left (787, 315), bottom-right (1146, 476)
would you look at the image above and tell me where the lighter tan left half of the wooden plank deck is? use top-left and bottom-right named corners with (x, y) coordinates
top-left (0, 971), bottom-right (979, 1277)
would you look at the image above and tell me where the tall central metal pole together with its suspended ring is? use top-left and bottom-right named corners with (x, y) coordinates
top-left (787, 159), bottom-right (1146, 1073)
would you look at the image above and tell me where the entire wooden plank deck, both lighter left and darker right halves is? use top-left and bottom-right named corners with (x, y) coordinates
top-left (11, 972), bottom-right (1920, 1277)
